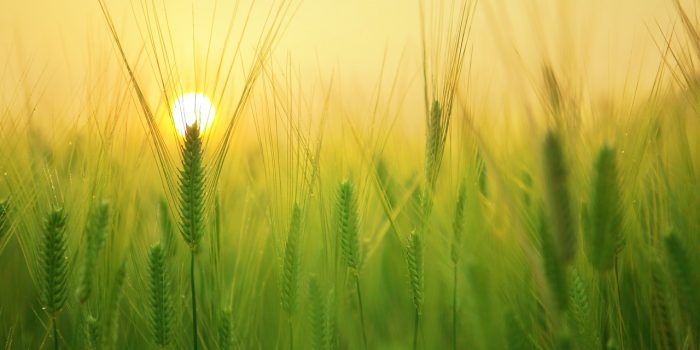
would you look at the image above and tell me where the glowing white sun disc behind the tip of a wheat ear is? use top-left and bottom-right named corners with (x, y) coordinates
top-left (173, 92), bottom-right (216, 136)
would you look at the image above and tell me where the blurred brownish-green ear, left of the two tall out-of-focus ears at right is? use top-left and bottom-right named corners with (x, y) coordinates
top-left (543, 131), bottom-right (576, 263)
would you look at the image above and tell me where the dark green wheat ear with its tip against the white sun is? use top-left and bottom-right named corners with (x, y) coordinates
top-left (179, 123), bottom-right (205, 251)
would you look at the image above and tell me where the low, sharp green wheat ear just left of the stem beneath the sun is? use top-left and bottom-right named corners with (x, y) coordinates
top-left (148, 243), bottom-right (173, 347)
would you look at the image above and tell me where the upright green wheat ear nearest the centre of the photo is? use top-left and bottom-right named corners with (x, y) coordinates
top-left (336, 180), bottom-right (360, 270)
